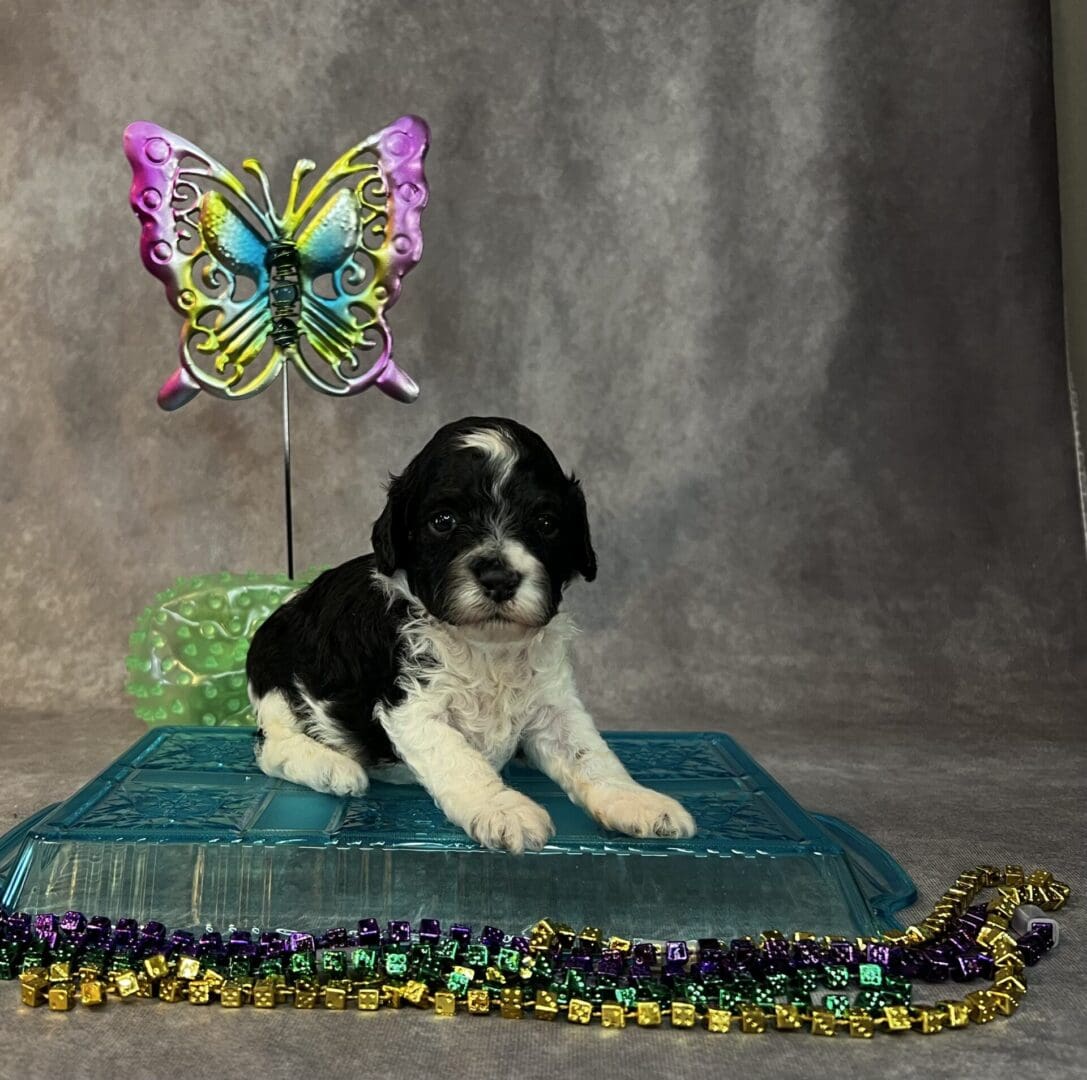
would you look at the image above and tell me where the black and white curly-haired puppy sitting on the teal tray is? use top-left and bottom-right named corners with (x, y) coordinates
top-left (248, 417), bottom-right (695, 852)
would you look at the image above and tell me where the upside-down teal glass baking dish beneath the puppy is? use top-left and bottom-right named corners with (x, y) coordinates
top-left (0, 727), bottom-right (916, 939)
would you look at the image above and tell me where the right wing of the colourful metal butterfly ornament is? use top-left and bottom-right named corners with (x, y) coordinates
top-left (285, 116), bottom-right (429, 402)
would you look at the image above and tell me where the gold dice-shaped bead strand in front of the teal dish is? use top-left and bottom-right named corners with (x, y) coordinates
top-left (20, 866), bottom-right (1071, 1039)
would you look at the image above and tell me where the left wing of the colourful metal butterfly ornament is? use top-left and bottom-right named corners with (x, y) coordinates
top-left (124, 122), bottom-right (284, 409)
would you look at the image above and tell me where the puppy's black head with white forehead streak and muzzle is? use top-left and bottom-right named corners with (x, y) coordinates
top-left (373, 416), bottom-right (597, 631)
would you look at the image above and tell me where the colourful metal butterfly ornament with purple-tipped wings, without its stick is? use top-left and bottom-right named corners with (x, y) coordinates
top-left (125, 116), bottom-right (429, 410)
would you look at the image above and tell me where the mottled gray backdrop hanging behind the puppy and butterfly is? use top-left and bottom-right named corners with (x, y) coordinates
top-left (0, 0), bottom-right (1084, 726)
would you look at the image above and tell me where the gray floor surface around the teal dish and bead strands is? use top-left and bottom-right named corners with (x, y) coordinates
top-left (0, 708), bottom-right (1087, 1080)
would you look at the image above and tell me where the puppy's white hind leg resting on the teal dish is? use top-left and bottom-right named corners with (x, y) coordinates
top-left (253, 690), bottom-right (370, 795)
